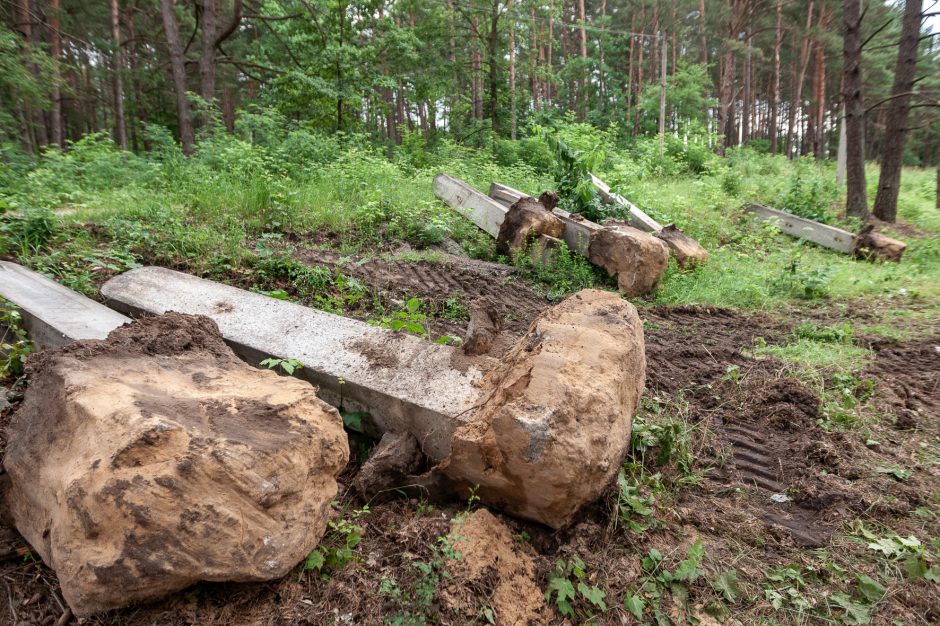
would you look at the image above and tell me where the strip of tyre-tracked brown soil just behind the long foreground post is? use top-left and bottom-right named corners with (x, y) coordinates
top-left (298, 250), bottom-right (550, 334)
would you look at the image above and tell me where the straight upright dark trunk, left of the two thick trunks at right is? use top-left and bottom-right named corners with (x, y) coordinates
top-left (842, 0), bottom-right (868, 219)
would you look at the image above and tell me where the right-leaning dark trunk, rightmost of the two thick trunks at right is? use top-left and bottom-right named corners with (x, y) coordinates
top-left (873, 0), bottom-right (923, 222)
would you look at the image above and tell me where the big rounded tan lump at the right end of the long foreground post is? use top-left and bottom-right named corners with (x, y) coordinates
top-left (437, 289), bottom-right (646, 528)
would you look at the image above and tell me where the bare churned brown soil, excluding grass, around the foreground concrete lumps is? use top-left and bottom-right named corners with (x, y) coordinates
top-left (0, 251), bottom-right (940, 626)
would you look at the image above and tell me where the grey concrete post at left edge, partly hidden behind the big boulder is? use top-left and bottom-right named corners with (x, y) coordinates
top-left (0, 261), bottom-right (130, 348)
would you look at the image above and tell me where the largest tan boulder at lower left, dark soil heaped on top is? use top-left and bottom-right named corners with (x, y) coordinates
top-left (4, 313), bottom-right (349, 616)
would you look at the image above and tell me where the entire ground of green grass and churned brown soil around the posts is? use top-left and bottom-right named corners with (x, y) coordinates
top-left (0, 138), bottom-right (940, 625)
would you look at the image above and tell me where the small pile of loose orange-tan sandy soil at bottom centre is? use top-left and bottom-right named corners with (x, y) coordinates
top-left (448, 509), bottom-right (551, 626)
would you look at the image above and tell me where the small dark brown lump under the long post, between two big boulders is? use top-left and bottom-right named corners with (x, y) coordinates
top-left (353, 433), bottom-right (424, 500)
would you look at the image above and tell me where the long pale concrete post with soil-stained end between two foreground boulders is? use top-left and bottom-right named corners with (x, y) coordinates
top-left (101, 267), bottom-right (495, 461)
